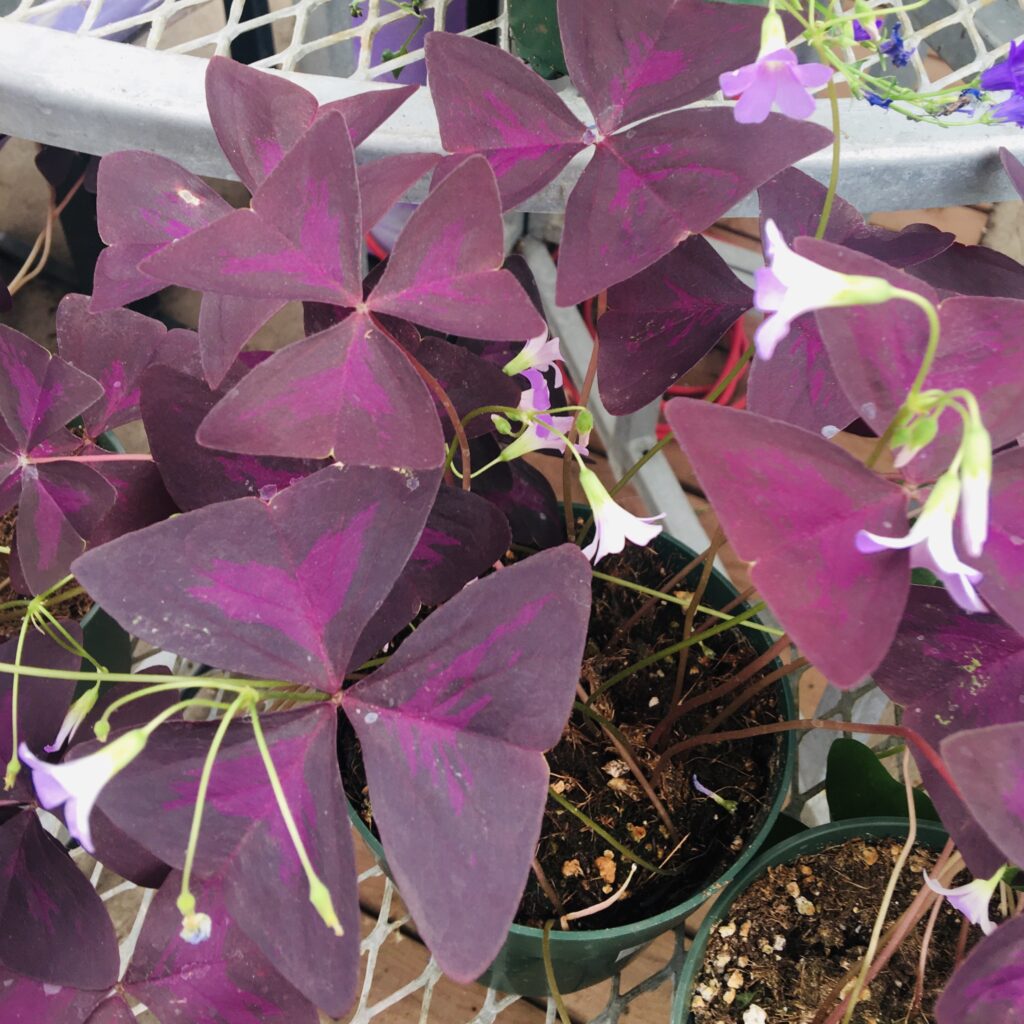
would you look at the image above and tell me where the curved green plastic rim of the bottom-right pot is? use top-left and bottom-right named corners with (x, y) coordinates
top-left (671, 818), bottom-right (947, 1024)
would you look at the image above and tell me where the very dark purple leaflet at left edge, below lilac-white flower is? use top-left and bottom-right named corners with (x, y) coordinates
top-left (0, 810), bottom-right (119, 991)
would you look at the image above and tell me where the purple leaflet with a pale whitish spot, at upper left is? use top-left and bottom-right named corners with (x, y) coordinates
top-left (92, 152), bottom-right (231, 312)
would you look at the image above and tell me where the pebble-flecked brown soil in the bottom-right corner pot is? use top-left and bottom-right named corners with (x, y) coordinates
top-left (691, 839), bottom-right (966, 1024)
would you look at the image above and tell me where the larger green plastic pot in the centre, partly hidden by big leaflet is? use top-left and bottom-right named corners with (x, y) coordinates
top-left (349, 528), bottom-right (796, 995)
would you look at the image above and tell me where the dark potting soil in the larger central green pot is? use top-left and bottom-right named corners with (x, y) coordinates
top-left (339, 548), bottom-right (783, 930)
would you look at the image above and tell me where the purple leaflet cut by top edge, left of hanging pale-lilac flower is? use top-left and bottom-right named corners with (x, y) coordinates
top-left (558, 0), bottom-right (764, 133)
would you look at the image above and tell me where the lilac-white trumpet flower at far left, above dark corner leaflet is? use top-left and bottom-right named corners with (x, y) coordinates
top-left (17, 729), bottom-right (148, 853)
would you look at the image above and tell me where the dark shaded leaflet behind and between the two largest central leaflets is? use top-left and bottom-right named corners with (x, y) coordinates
top-left (352, 486), bottom-right (512, 669)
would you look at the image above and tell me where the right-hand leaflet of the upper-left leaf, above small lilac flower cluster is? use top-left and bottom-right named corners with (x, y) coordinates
top-left (369, 157), bottom-right (544, 341)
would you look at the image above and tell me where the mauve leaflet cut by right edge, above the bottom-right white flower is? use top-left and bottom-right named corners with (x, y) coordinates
top-left (940, 721), bottom-right (1024, 864)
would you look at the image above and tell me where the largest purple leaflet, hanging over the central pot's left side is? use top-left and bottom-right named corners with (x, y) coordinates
top-left (343, 545), bottom-right (591, 982)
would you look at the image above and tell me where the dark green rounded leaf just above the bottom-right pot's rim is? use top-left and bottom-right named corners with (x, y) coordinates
top-left (825, 736), bottom-right (939, 821)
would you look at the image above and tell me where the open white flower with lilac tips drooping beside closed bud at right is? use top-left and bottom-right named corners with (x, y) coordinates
top-left (855, 472), bottom-right (988, 611)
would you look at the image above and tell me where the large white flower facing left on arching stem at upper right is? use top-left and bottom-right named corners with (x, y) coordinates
top-left (754, 220), bottom-right (893, 359)
